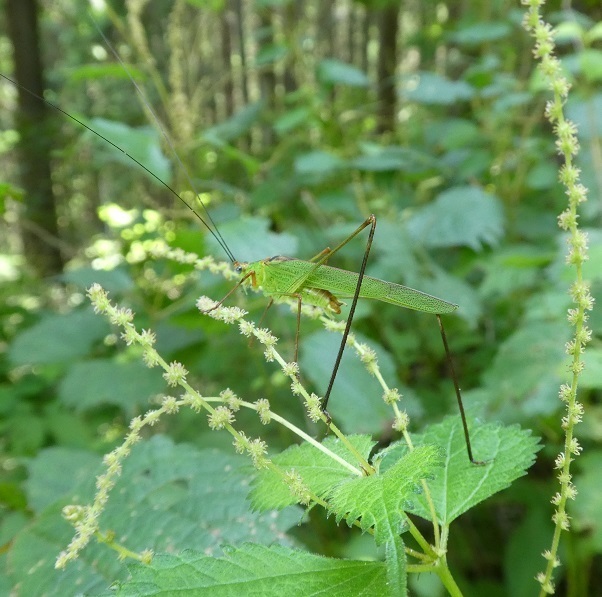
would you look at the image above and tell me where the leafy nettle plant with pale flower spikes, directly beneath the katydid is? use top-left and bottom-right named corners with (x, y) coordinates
top-left (51, 245), bottom-right (538, 595)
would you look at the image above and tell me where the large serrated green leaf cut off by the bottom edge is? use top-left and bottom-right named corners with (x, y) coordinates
top-left (107, 544), bottom-right (386, 597)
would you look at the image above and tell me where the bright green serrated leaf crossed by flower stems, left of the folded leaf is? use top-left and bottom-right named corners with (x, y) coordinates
top-left (249, 435), bottom-right (376, 510)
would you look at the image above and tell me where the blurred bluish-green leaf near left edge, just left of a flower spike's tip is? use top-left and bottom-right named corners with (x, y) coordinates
top-left (8, 308), bottom-right (110, 365)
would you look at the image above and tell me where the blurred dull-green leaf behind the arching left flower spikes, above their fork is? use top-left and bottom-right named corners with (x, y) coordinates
top-left (58, 359), bottom-right (165, 416)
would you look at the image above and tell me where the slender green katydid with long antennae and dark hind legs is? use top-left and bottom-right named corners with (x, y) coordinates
top-left (0, 32), bottom-right (483, 464)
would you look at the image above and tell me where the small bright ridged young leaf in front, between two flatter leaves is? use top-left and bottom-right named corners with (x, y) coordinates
top-left (327, 445), bottom-right (443, 545)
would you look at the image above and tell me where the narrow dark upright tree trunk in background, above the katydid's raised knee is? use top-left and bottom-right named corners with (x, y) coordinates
top-left (377, 4), bottom-right (400, 133)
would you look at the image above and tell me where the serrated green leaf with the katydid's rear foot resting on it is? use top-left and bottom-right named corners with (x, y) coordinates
top-left (377, 417), bottom-right (540, 525)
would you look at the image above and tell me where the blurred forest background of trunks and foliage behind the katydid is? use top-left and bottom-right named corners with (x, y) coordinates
top-left (0, 0), bottom-right (602, 596)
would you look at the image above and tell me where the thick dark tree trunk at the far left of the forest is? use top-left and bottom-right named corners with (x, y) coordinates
top-left (7, 0), bottom-right (64, 276)
